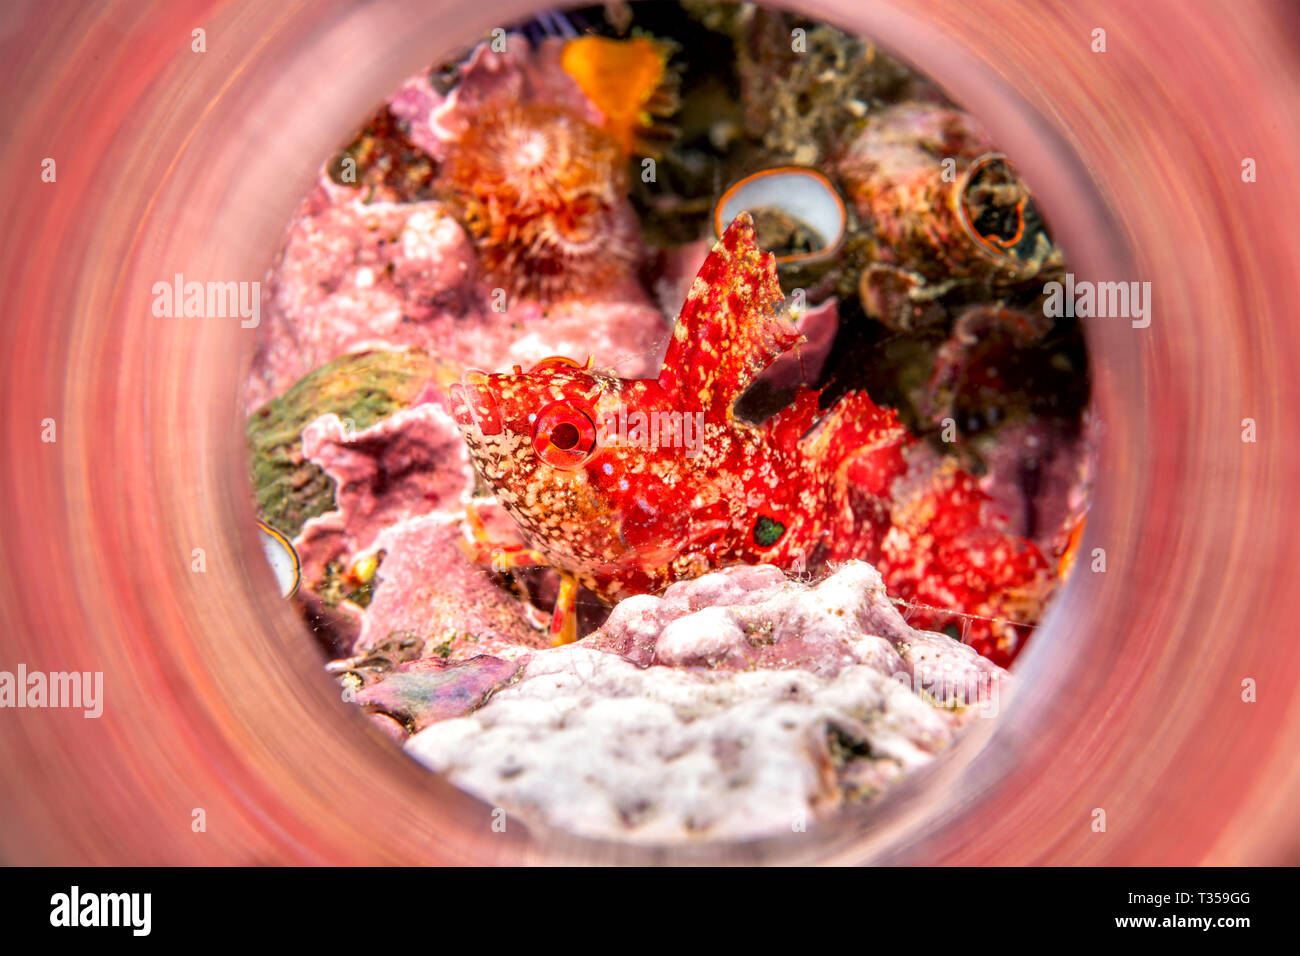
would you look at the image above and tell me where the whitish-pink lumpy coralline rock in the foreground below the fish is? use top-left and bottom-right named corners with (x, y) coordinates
top-left (403, 562), bottom-right (1010, 844)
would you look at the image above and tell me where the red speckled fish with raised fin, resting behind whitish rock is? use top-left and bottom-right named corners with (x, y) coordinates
top-left (452, 213), bottom-right (1050, 658)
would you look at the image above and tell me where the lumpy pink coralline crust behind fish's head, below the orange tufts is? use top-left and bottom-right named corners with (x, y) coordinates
top-left (244, 183), bottom-right (668, 408)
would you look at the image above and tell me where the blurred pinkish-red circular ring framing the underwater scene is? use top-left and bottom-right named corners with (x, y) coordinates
top-left (0, 0), bottom-right (1300, 864)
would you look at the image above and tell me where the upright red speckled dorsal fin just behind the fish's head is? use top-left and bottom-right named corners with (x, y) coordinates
top-left (659, 212), bottom-right (801, 415)
